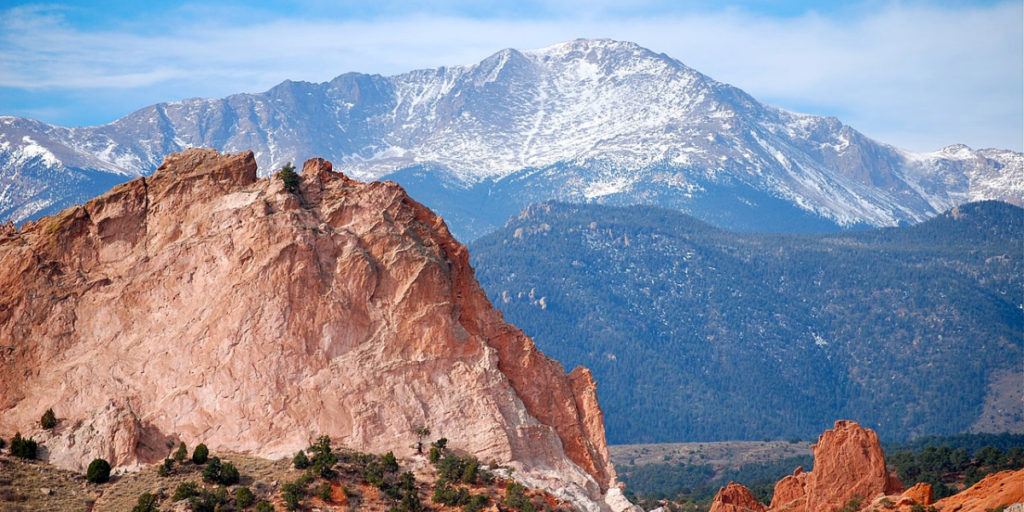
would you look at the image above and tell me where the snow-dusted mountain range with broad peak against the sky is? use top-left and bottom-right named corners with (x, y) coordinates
top-left (0, 40), bottom-right (1024, 240)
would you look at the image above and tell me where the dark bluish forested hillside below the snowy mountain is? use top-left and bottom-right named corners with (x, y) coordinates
top-left (470, 202), bottom-right (1024, 443)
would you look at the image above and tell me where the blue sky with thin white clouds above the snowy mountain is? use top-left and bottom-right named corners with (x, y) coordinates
top-left (0, 0), bottom-right (1024, 152)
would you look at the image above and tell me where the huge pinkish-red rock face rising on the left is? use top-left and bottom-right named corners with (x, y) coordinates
top-left (0, 150), bottom-right (629, 511)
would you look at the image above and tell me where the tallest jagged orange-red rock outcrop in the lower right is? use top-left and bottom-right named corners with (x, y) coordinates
top-left (771, 421), bottom-right (902, 512)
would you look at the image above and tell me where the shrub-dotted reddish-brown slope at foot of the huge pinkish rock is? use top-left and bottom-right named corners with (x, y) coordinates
top-left (0, 437), bottom-right (565, 512)
